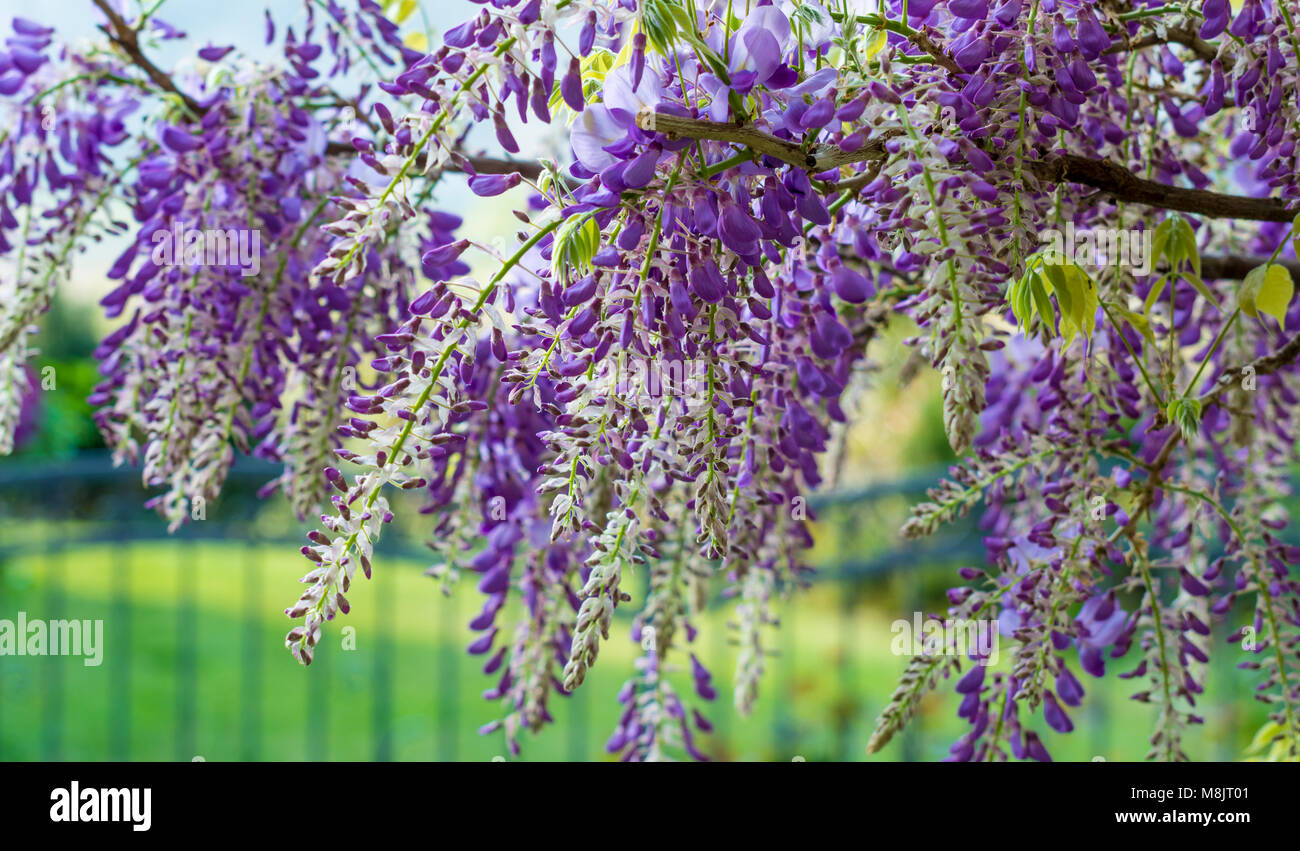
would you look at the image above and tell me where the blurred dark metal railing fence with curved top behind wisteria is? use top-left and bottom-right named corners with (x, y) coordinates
top-left (0, 456), bottom-right (1258, 760)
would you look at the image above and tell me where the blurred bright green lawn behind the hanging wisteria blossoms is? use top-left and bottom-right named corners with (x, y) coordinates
top-left (0, 542), bottom-right (1264, 761)
